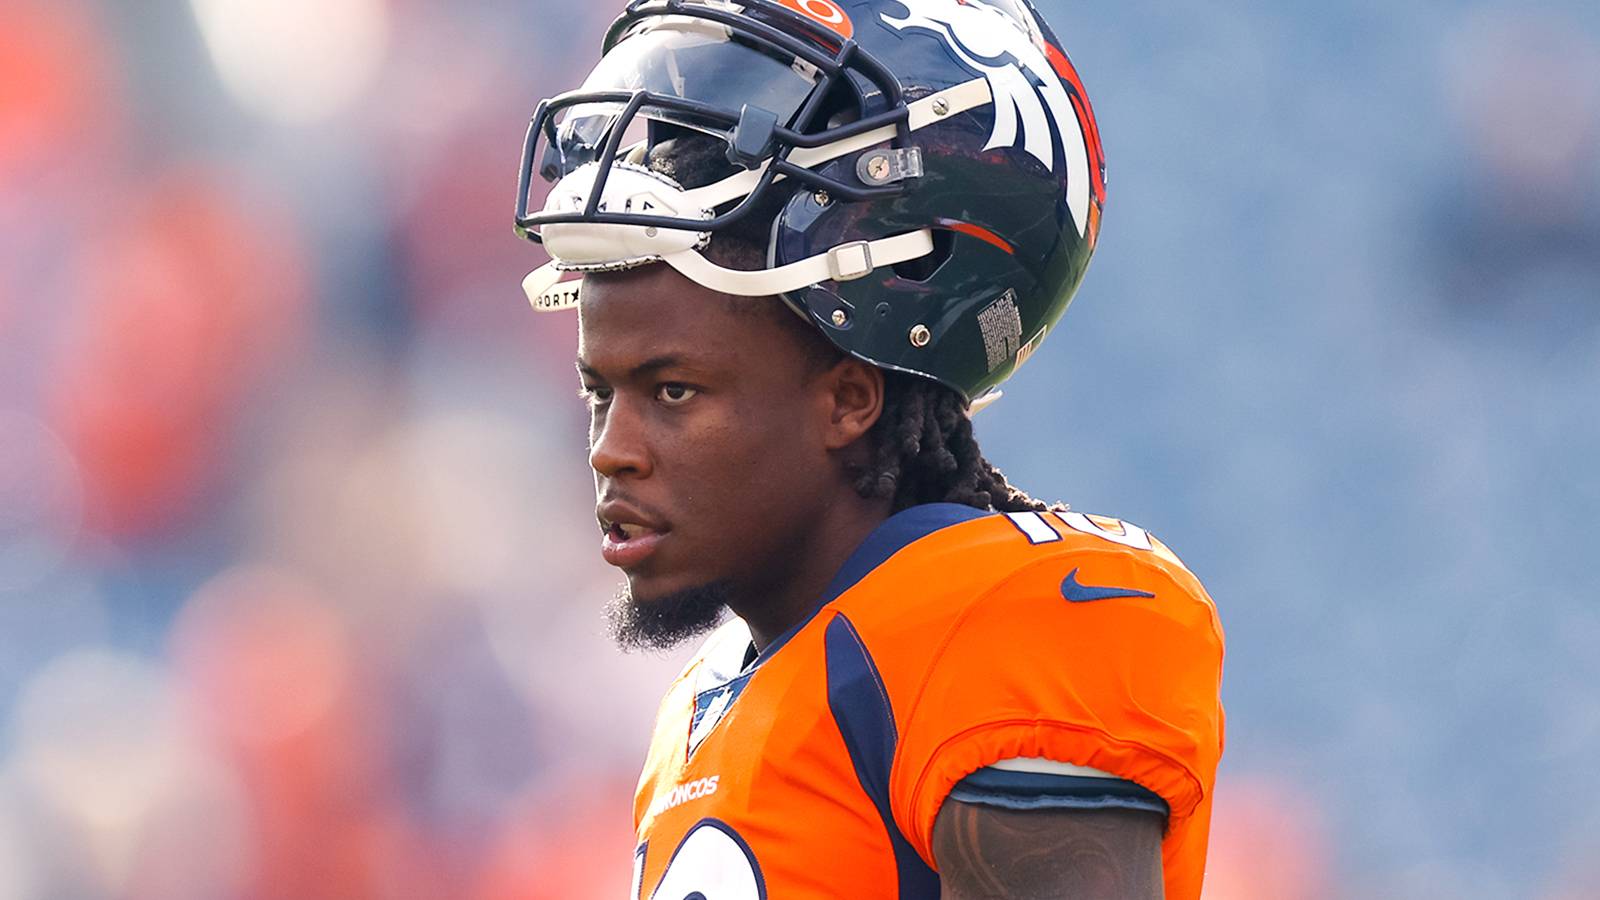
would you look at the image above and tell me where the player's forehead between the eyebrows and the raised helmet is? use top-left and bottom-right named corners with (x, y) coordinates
top-left (578, 264), bottom-right (797, 372)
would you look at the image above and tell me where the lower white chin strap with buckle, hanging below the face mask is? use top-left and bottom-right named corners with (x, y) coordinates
top-left (522, 229), bottom-right (933, 312)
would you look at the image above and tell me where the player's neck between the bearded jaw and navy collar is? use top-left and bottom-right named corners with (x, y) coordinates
top-left (728, 492), bottom-right (893, 652)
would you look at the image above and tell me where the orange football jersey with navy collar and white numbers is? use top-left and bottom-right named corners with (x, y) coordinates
top-left (634, 504), bottom-right (1222, 900)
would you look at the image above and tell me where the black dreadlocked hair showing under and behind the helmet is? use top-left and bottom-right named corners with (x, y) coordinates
top-left (648, 133), bottom-right (1064, 512)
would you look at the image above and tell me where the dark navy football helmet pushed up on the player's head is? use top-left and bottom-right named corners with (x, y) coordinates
top-left (517, 0), bottom-right (1106, 404)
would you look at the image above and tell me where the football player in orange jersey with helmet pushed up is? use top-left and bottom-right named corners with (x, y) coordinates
top-left (517, 0), bottom-right (1222, 900)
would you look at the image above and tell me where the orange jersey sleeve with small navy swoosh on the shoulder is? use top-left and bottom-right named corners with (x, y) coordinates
top-left (891, 548), bottom-right (1222, 868)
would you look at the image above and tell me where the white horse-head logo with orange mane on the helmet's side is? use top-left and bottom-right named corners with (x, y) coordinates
top-left (882, 0), bottom-right (1090, 237)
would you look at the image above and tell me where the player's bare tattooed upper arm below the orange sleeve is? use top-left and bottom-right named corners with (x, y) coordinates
top-left (933, 799), bottom-right (1165, 900)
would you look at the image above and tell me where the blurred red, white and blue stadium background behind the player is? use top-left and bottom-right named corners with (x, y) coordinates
top-left (0, 0), bottom-right (1600, 900)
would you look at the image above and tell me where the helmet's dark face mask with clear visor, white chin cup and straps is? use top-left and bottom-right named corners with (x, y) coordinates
top-left (517, 0), bottom-right (989, 309)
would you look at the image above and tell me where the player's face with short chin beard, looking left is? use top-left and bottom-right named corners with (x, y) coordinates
top-left (578, 264), bottom-right (838, 634)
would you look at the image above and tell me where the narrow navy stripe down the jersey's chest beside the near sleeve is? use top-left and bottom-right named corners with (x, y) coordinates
top-left (822, 613), bottom-right (939, 900)
